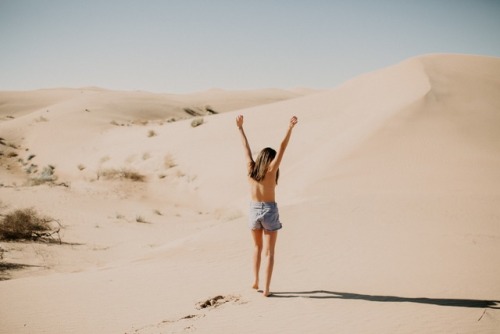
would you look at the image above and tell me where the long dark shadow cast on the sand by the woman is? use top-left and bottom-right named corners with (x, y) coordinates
top-left (270, 290), bottom-right (500, 309)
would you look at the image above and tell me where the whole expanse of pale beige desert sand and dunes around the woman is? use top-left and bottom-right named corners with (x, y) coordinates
top-left (0, 55), bottom-right (500, 334)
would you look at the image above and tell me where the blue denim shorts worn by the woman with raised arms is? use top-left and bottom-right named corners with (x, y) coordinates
top-left (248, 202), bottom-right (282, 231)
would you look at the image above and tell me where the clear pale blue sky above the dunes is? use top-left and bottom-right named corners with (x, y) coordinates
top-left (0, 0), bottom-right (500, 93)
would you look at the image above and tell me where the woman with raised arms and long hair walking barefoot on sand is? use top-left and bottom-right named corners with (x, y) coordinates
top-left (236, 115), bottom-right (297, 297)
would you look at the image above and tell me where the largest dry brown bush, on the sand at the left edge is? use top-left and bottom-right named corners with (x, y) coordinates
top-left (0, 208), bottom-right (51, 240)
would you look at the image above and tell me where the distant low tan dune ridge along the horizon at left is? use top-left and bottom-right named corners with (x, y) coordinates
top-left (0, 87), bottom-right (317, 121)
